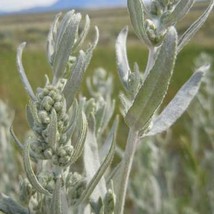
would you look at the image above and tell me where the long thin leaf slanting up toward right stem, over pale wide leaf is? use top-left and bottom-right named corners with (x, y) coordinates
top-left (77, 117), bottom-right (118, 205)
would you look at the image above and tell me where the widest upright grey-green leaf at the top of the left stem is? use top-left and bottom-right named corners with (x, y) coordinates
top-left (53, 11), bottom-right (81, 84)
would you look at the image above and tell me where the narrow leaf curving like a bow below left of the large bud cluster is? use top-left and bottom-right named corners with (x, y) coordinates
top-left (23, 141), bottom-right (51, 196)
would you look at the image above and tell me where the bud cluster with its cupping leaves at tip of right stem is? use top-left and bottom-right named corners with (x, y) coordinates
top-left (128, 0), bottom-right (181, 47)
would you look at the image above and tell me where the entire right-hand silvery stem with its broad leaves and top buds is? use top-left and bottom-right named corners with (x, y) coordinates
top-left (113, 0), bottom-right (214, 214)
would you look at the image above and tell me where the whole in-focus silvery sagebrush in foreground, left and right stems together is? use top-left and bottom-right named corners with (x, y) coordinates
top-left (0, 0), bottom-right (214, 214)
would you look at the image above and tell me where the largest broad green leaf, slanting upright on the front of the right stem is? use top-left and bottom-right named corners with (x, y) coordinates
top-left (125, 27), bottom-right (177, 130)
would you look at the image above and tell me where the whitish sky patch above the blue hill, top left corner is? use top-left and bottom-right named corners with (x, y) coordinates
top-left (0, 0), bottom-right (57, 12)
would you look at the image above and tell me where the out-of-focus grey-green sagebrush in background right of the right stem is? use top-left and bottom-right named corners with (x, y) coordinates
top-left (128, 53), bottom-right (214, 214)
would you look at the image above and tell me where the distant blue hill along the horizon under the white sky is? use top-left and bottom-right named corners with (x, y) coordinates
top-left (0, 0), bottom-right (126, 15)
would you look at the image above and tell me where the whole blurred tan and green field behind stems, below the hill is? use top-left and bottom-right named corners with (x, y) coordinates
top-left (0, 4), bottom-right (214, 140)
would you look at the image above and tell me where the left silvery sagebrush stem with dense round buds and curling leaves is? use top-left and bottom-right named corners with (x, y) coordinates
top-left (0, 11), bottom-right (118, 214)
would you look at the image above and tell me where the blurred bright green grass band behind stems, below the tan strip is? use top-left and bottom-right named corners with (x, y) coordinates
top-left (0, 42), bottom-right (214, 138)
